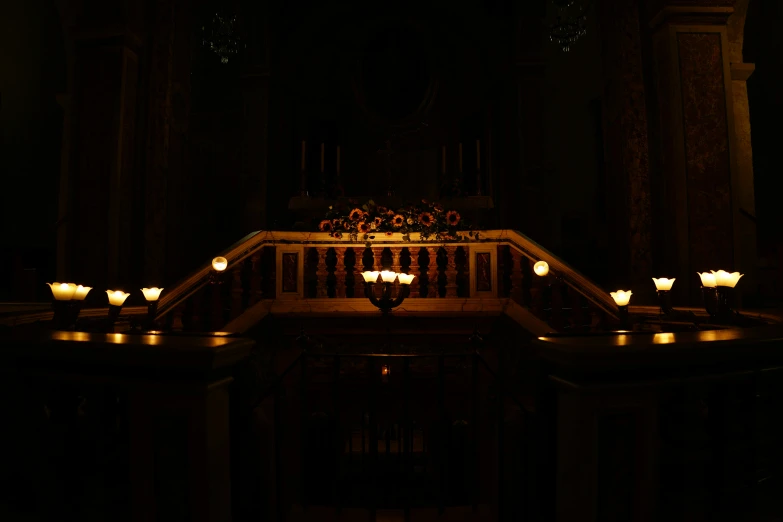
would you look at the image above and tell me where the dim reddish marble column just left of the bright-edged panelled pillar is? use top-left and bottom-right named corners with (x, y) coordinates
top-left (598, 0), bottom-right (656, 300)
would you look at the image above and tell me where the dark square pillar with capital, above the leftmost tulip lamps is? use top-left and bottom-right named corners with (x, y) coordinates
top-left (67, 21), bottom-right (140, 288)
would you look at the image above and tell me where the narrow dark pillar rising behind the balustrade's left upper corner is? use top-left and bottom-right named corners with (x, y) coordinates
top-left (241, 2), bottom-right (269, 232)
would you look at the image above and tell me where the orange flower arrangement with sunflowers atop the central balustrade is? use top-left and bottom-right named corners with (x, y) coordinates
top-left (318, 199), bottom-right (473, 241)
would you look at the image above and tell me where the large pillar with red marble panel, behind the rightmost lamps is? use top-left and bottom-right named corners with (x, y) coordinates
top-left (647, 0), bottom-right (755, 302)
